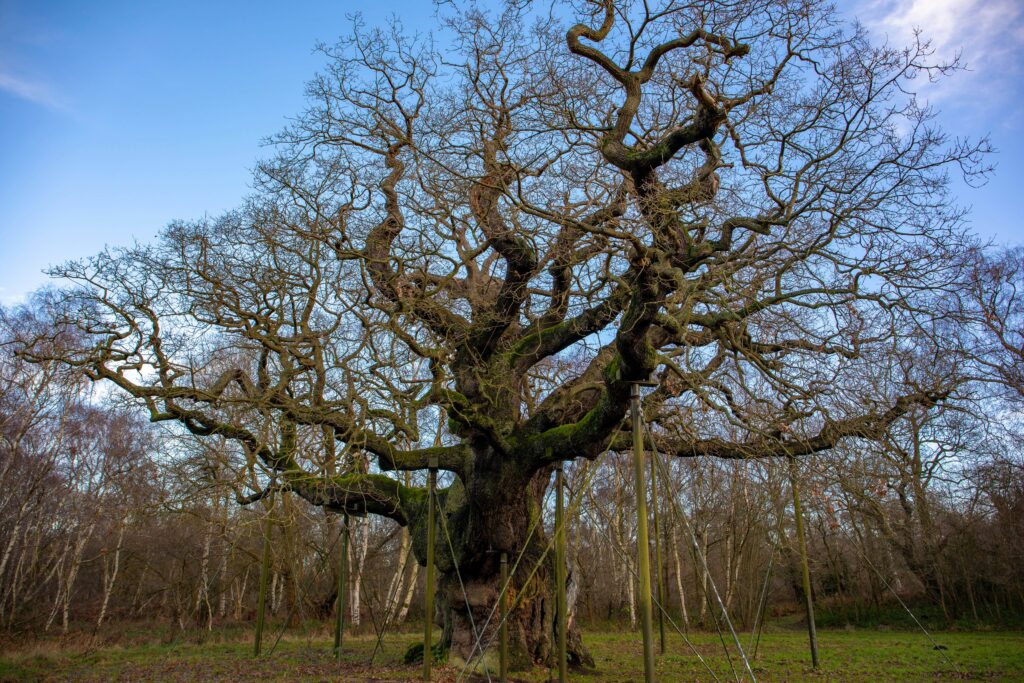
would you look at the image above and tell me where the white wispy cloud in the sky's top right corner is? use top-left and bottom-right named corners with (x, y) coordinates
top-left (855, 0), bottom-right (1024, 123)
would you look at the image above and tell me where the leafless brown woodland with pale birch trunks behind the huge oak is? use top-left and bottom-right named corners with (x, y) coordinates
top-left (0, 251), bottom-right (1024, 638)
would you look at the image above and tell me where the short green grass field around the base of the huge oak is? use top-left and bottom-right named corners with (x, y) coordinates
top-left (0, 629), bottom-right (1024, 683)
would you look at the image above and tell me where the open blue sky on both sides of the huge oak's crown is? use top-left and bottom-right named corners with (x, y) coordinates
top-left (0, 0), bottom-right (1024, 303)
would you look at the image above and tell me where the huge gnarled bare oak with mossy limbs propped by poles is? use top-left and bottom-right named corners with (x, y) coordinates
top-left (27, 0), bottom-right (986, 666)
